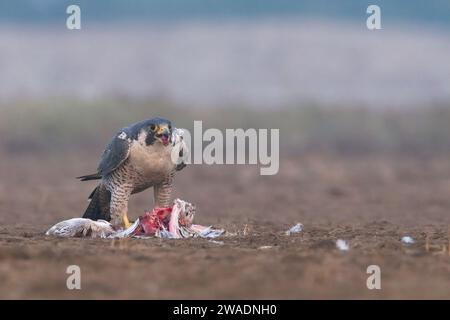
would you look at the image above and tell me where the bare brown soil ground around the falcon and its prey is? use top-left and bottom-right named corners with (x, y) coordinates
top-left (0, 152), bottom-right (450, 299)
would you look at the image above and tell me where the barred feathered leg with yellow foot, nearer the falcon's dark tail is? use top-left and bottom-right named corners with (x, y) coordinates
top-left (111, 185), bottom-right (132, 228)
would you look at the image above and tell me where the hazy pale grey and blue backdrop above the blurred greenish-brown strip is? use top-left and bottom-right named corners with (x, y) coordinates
top-left (0, 0), bottom-right (450, 108)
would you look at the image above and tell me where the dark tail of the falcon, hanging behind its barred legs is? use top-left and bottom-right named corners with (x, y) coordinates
top-left (83, 184), bottom-right (111, 221)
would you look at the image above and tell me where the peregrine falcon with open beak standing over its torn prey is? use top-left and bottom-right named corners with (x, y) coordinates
top-left (77, 117), bottom-right (187, 228)
